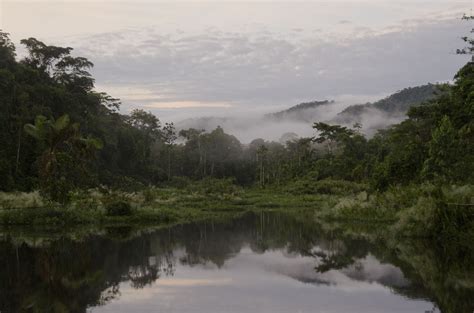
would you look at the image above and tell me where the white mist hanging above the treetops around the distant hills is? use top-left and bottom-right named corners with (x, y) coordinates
top-left (174, 94), bottom-right (392, 144)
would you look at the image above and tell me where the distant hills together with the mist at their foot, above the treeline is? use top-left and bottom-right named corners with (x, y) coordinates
top-left (176, 84), bottom-right (438, 142)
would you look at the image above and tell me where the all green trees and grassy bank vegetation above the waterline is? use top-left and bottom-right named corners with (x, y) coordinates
top-left (0, 22), bottom-right (474, 246)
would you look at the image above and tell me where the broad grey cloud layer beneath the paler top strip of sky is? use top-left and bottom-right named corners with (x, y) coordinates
top-left (75, 15), bottom-right (462, 119)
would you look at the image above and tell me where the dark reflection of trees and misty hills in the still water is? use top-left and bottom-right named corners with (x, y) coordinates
top-left (0, 212), bottom-right (474, 313)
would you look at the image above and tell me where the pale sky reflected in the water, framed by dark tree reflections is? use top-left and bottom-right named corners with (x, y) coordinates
top-left (92, 224), bottom-right (433, 313)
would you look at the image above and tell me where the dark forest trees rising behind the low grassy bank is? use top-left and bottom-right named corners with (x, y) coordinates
top-left (0, 29), bottom-right (474, 198)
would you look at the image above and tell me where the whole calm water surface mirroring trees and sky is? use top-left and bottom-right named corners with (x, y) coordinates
top-left (0, 213), bottom-right (474, 313)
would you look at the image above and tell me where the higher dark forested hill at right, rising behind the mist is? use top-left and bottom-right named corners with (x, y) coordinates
top-left (334, 84), bottom-right (438, 123)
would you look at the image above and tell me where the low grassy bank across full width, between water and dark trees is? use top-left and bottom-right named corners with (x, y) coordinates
top-left (0, 181), bottom-right (474, 241)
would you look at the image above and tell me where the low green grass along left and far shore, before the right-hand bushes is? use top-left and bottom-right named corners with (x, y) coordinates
top-left (0, 182), bottom-right (328, 225)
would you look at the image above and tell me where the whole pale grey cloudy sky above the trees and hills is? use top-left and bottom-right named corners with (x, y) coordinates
top-left (0, 0), bottom-right (472, 120)
